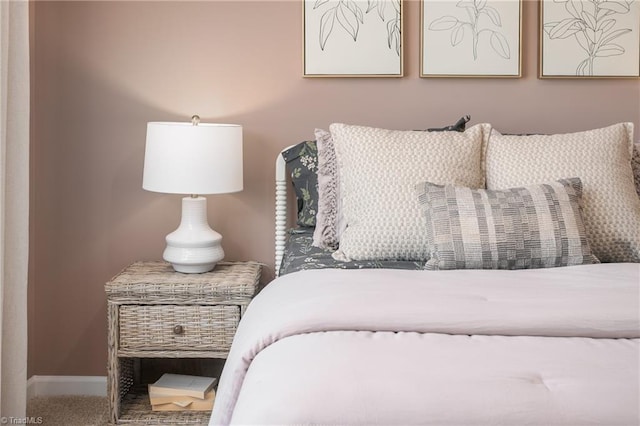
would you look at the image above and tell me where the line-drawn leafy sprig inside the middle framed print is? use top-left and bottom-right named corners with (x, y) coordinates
top-left (428, 0), bottom-right (511, 61)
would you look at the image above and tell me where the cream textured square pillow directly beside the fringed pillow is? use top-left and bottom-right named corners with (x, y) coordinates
top-left (330, 123), bottom-right (491, 261)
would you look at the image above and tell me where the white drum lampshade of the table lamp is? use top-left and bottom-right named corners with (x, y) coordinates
top-left (142, 122), bottom-right (243, 194)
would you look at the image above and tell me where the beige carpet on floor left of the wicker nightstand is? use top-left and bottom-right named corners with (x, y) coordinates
top-left (27, 396), bottom-right (109, 426)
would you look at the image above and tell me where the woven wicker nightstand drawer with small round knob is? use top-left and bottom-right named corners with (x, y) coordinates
top-left (119, 305), bottom-right (240, 351)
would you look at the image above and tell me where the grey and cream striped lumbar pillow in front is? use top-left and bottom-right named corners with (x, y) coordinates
top-left (416, 178), bottom-right (599, 269)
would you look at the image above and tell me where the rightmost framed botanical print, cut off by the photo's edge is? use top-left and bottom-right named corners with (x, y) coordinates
top-left (539, 0), bottom-right (640, 78)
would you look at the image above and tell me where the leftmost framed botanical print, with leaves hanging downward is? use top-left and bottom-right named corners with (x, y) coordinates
top-left (303, 0), bottom-right (403, 77)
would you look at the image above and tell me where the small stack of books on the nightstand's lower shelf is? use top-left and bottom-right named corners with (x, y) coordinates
top-left (149, 373), bottom-right (217, 411)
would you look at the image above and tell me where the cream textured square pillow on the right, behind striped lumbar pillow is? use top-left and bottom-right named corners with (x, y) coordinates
top-left (485, 123), bottom-right (640, 262)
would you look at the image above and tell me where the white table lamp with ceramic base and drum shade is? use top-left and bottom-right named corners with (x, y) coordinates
top-left (142, 116), bottom-right (243, 273)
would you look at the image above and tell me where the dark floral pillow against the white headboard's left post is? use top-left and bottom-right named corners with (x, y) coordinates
top-left (282, 141), bottom-right (318, 227)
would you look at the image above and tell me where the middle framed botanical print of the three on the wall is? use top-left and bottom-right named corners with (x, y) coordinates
top-left (420, 0), bottom-right (522, 78)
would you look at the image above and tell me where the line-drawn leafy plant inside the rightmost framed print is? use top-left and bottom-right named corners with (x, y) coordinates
top-left (543, 0), bottom-right (634, 76)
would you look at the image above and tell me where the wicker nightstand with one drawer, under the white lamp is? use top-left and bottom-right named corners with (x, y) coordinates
top-left (105, 262), bottom-right (262, 425)
